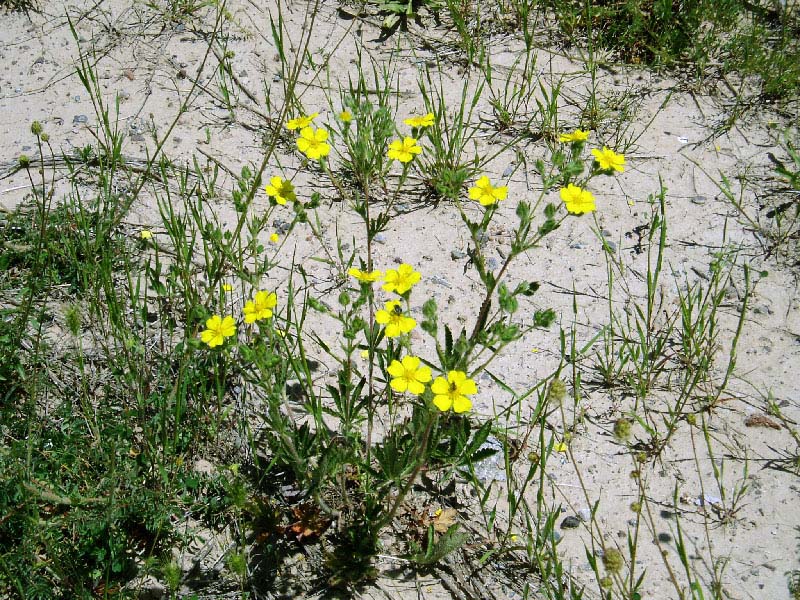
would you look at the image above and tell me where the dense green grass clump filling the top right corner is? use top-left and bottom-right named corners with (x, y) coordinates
top-left (541, 0), bottom-right (800, 99)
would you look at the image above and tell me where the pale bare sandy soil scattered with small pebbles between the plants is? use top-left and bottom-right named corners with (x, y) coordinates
top-left (0, 0), bottom-right (800, 600)
